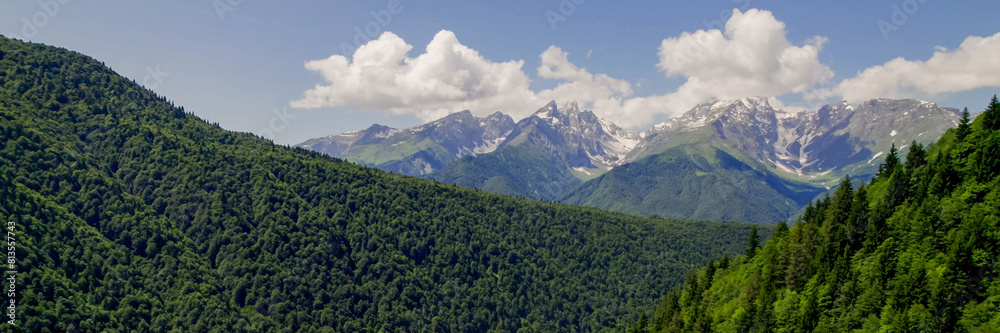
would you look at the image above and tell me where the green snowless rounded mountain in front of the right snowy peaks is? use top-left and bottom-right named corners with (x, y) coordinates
top-left (561, 134), bottom-right (825, 224)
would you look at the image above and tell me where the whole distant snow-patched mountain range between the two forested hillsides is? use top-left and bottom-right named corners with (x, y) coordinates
top-left (297, 98), bottom-right (960, 223)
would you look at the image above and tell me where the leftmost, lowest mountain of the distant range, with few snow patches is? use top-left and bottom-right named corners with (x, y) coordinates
top-left (296, 111), bottom-right (514, 176)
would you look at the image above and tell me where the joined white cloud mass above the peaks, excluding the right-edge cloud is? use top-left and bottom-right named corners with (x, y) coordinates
top-left (291, 9), bottom-right (833, 127)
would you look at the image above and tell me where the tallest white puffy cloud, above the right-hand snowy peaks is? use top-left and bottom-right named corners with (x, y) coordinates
top-left (624, 9), bottom-right (833, 120)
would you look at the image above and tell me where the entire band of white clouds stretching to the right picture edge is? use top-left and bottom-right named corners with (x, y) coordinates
top-left (291, 9), bottom-right (1000, 128)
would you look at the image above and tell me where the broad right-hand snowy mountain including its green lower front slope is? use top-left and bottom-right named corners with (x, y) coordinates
top-left (560, 98), bottom-right (958, 224)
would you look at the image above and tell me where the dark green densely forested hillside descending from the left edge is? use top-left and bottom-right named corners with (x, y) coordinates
top-left (0, 38), bottom-right (764, 332)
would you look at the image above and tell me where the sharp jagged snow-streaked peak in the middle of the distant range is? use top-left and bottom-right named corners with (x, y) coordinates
top-left (430, 102), bottom-right (638, 200)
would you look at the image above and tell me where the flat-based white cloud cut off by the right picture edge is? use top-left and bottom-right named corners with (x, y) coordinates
top-left (812, 33), bottom-right (1000, 102)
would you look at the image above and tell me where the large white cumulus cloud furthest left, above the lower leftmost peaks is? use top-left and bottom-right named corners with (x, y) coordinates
top-left (291, 31), bottom-right (537, 120)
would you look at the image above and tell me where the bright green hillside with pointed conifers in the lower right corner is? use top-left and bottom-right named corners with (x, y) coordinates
top-left (633, 97), bottom-right (1000, 332)
